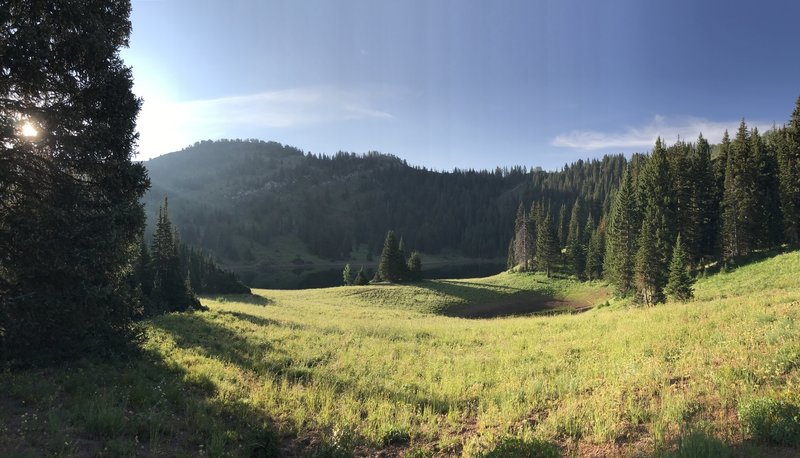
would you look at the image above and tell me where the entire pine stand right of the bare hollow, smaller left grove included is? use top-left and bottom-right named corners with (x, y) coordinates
top-left (508, 99), bottom-right (800, 304)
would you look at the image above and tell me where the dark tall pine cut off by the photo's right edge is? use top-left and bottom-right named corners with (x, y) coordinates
top-left (778, 97), bottom-right (800, 246)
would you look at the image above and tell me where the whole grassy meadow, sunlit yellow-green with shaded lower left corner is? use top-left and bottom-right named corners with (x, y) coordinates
top-left (0, 252), bottom-right (800, 456)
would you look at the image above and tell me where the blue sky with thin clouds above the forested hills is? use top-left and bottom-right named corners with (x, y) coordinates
top-left (122, 0), bottom-right (800, 170)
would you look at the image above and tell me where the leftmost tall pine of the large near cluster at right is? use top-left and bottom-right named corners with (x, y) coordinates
top-left (603, 166), bottom-right (639, 297)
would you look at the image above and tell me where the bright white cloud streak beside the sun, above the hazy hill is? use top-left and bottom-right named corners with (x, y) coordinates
top-left (137, 87), bottom-right (392, 159)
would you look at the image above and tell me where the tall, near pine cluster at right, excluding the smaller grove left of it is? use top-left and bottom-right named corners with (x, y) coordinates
top-left (605, 99), bottom-right (800, 304)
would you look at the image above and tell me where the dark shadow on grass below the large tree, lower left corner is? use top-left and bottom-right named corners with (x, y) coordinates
top-left (0, 336), bottom-right (284, 457)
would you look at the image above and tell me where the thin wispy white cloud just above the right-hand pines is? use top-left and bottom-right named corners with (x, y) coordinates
top-left (550, 115), bottom-right (772, 151)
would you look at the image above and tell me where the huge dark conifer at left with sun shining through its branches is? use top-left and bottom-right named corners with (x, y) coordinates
top-left (0, 0), bottom-right (149, 361)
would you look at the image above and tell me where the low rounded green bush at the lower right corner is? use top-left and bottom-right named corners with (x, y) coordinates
top-left (739, 398), bottom-right (800, 445)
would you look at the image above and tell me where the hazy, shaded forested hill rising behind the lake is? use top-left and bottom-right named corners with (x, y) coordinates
top-left (145, 140), bottom-right (626, 288)
